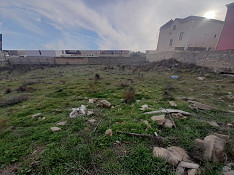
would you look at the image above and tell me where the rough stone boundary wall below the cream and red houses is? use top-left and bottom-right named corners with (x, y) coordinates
top-left (146, 51), bottom-right (234, 73)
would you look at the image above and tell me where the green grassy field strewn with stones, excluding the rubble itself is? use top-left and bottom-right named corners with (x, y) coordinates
top-left (0, 66), bottom-right (234, 175)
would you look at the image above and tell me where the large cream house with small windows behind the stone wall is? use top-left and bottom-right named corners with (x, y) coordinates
top-left (157, 16), bottom-right (224, 51)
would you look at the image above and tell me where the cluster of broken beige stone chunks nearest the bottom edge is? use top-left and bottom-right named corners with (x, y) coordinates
top-left (153, 146), bottom-right (200, 175)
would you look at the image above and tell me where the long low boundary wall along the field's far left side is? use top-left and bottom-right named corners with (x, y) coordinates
top-left (8, 57), bottom-right (146, 65)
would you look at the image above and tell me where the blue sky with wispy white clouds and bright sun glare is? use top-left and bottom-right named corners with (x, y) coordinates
top-left (0, 0), bottom-right (233, 51)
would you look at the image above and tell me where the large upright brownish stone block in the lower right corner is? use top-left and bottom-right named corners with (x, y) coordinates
top-left (195, 133), bottom-right (229, 163)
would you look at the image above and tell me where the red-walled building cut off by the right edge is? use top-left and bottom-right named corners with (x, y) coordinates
top-left (216, 3), bottom-right (234, 50)
